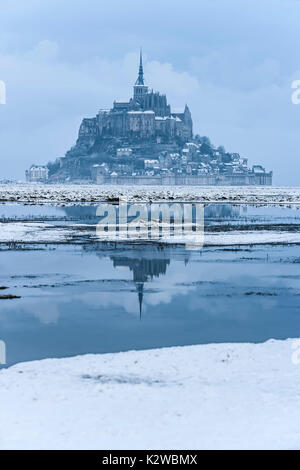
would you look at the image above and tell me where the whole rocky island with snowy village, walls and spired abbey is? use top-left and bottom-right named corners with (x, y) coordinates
top-left (26, 53), bottom-right (272, 185)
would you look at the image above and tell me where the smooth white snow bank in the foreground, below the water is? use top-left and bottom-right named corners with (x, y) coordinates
top-left (0, 340), bottom-right (300, 449)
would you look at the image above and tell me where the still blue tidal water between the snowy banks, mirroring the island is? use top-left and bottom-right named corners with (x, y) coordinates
top-left (0, 204), bottom-right (300, 365)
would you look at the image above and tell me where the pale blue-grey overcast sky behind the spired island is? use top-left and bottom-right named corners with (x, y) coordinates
top-left (0, 0), bottom-right (300, 185)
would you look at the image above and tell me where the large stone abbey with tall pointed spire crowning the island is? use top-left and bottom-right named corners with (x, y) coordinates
top-left (79, 53), bottom-right (193, 143)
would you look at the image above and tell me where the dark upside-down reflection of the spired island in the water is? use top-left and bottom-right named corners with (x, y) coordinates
top-left (68, 204), bottom-right (241, 318)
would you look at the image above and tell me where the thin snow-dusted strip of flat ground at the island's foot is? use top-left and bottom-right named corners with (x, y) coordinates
top-left (0, 184), bottom-right (300, 204)
